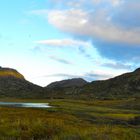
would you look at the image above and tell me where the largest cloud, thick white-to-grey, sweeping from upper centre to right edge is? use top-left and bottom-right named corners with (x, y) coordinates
top-left (48, 9), bottom-right (140, 44)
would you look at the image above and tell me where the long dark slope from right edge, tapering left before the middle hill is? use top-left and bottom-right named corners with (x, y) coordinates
top-left (46, 68), bottom-right (140, 99)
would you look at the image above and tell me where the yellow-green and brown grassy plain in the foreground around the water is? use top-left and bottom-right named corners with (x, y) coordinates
top-left (0, 99), bottom-right (140, 140)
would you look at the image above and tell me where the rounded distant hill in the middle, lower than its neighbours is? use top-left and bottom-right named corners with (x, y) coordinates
top-left (45, 78), bottom-right (88, 98)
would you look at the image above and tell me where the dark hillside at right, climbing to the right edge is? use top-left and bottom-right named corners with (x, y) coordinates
top-left (81, 68), bottom-right (140, 98)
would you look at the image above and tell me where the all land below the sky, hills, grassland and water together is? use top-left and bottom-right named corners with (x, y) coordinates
top-left (0, 68), bottom-right (140, 140)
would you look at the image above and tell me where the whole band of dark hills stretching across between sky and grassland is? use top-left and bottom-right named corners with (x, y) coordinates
top-left (0, 67), bottom-right (140, 99)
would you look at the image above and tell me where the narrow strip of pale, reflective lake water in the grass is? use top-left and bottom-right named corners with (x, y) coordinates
top-left (0, 102), bottom-right (50, 108)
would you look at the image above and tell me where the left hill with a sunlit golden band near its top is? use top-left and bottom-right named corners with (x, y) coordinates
top-left (0, 67), bottom-right (43, 98)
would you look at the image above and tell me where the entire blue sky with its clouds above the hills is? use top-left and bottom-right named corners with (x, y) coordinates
top-left (0, 0), bottom-right (140, 86)
